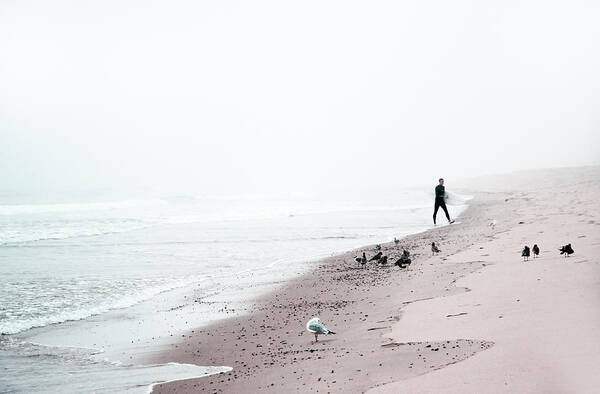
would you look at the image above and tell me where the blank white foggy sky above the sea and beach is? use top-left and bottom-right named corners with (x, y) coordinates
top-left (0, 0), bottom-right (600, 197)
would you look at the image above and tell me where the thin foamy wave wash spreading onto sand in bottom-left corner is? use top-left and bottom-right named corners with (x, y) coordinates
top-left (0, 338), bottom-right (232, 394)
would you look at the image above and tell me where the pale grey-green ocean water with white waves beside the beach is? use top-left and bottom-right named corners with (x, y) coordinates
top-left (0, 190), bottom-right (466, 393)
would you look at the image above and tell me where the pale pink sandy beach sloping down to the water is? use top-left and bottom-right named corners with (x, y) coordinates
top-left (152, 167), bottom-right (600, 393)
